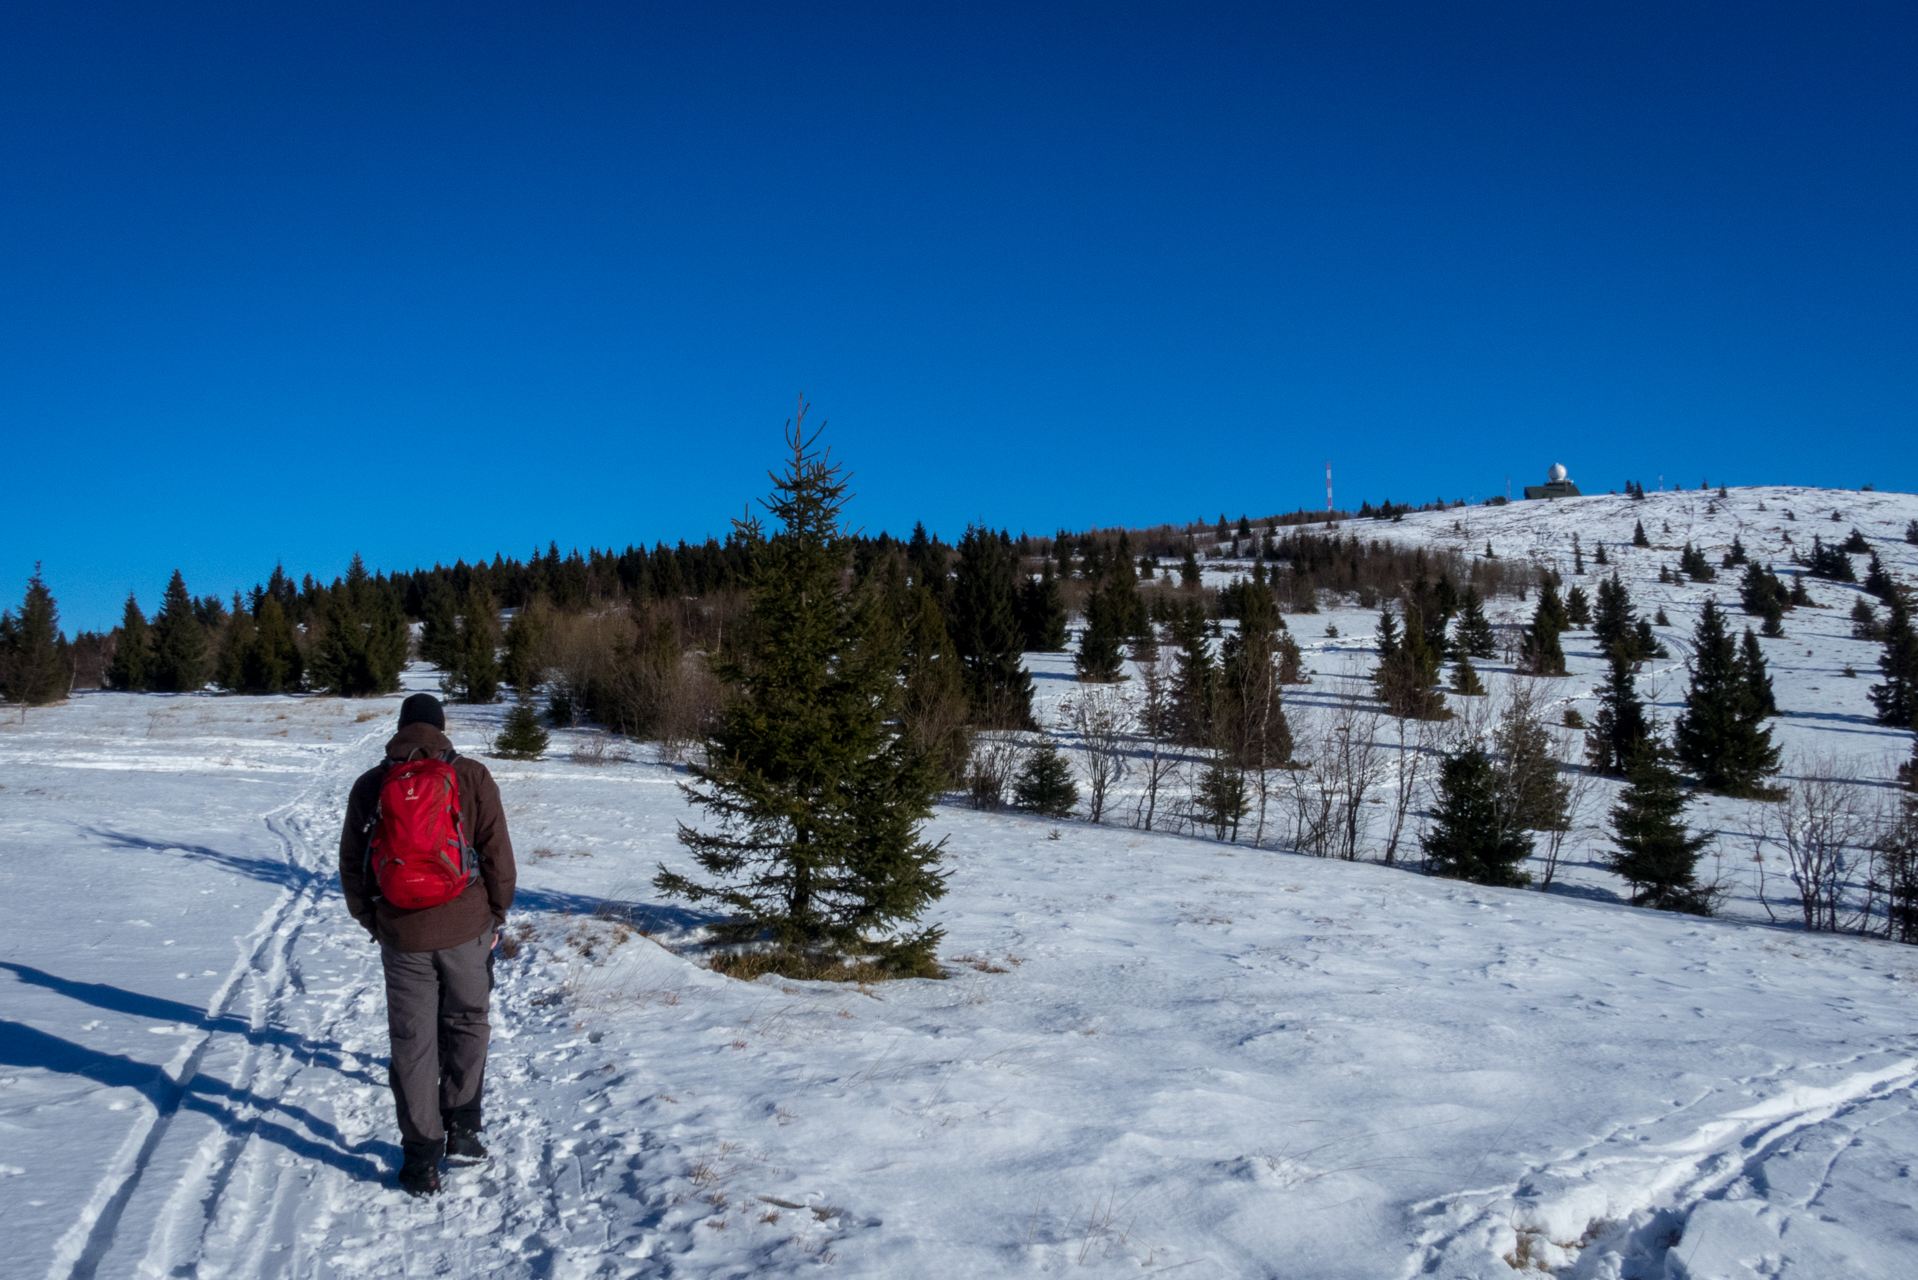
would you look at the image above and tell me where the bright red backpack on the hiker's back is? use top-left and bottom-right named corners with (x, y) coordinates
top-left (366, 758), bottom-right (480, 910)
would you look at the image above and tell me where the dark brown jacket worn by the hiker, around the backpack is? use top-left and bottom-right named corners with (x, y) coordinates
top-left (339, 723), bottom-right (518, 952)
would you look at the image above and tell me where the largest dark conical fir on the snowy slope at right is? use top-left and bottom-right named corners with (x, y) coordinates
top-left (1672, 599), bottom-right (1778, 796)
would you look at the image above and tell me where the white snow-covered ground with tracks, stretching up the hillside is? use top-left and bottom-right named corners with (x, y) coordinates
top-left (0, 489), bottom-right (1918, 1280)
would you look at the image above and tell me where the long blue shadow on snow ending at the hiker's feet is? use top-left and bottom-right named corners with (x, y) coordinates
top-left (0, 1021), bottom-right (399, 1182)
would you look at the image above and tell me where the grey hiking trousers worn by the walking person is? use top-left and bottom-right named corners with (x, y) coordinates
top-left (380, 929), bottom-right (493, 1151)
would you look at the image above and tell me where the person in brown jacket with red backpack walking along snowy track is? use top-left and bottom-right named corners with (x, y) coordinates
top-left (339, 693), bottom-right (516, 1196)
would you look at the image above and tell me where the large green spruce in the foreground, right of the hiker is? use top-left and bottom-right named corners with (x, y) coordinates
top-left (654, 420), bottom-right (947, 973)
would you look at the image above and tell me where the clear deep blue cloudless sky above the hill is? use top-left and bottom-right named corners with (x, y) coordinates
top-left (0, 0), bottom-right (1918, 629)
